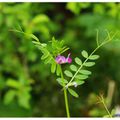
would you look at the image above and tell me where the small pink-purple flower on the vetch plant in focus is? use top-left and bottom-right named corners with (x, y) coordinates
top-left (55, 53), bottom-right (72, 64)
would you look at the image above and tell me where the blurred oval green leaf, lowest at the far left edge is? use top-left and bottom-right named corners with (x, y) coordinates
top-left (4, 90), bottom-right (16, 105)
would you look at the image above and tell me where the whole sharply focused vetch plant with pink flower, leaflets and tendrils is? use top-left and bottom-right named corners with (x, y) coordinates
top-left (14, 30), bottom-right (118, 117)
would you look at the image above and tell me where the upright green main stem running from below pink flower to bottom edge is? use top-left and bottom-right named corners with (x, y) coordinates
top-left (61, 65), bottom-right (70, 118)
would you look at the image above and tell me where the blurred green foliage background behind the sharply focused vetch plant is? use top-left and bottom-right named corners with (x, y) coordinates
top-left (0, 3), bottom-right (120, 117)
